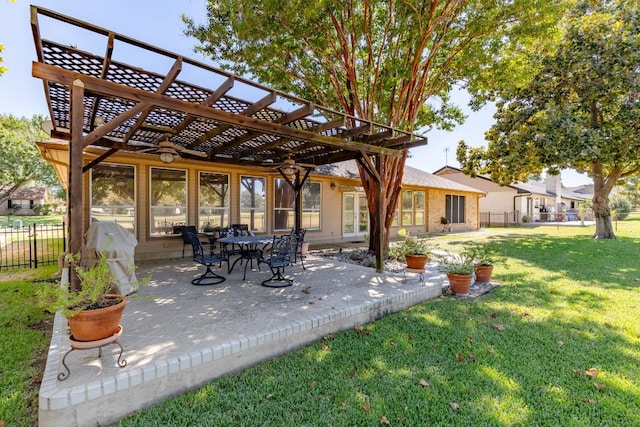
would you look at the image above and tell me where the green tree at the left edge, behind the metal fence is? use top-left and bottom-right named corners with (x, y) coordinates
top-left (0, 114), bottom-right (59, 203)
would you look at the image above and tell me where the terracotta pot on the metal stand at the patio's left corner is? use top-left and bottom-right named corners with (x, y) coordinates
top-left (67, 295), bottom-right (127, 341)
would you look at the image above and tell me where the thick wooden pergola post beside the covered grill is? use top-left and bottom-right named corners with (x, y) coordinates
top-left (67, 80), bottom-right (84, 291)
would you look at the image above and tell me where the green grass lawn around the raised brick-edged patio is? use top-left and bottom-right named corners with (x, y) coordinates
top-left (0, 214), bottom-right (640, 426)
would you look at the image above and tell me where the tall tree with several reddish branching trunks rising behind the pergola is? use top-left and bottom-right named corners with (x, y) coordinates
top-left (184, 0), bottom-right (563, 249)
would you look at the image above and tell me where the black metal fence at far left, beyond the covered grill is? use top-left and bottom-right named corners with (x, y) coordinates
top-left (0, 223), bottom-right (67, 270)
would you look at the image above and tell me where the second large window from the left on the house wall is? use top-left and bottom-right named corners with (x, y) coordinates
top-left (149, 168), bottom-right (187, 237)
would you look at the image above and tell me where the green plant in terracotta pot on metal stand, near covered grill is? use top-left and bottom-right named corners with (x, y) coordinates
top-left (38, 255), bottom-right (127, 341)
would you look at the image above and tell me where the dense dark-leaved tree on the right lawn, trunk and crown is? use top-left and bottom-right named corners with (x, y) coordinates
top-left (457, 0), bottom-right (640, 238)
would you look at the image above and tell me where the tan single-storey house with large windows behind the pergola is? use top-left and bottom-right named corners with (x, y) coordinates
top-left (38, 141), bottom-right (483, 260)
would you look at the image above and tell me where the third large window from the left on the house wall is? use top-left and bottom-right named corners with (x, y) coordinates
top-left (198, 172), bottom-right (229, 230)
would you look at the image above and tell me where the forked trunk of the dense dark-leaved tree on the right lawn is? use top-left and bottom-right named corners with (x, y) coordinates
top-left (591, 162), bottom-right (622, 239)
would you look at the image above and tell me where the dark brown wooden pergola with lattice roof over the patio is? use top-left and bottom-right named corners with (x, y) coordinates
top-left (31, 6), bottom-right (427, 271)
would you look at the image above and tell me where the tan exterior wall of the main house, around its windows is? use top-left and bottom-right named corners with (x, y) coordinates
top-left (40, 147), bottom-right (479, 260)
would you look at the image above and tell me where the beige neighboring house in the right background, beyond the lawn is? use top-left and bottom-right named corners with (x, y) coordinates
top-left (434, 166), bottom-right (589, 224)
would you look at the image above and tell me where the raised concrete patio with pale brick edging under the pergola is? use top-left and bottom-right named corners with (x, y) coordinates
top-left (39, 252), bottom-right (446, 426)
